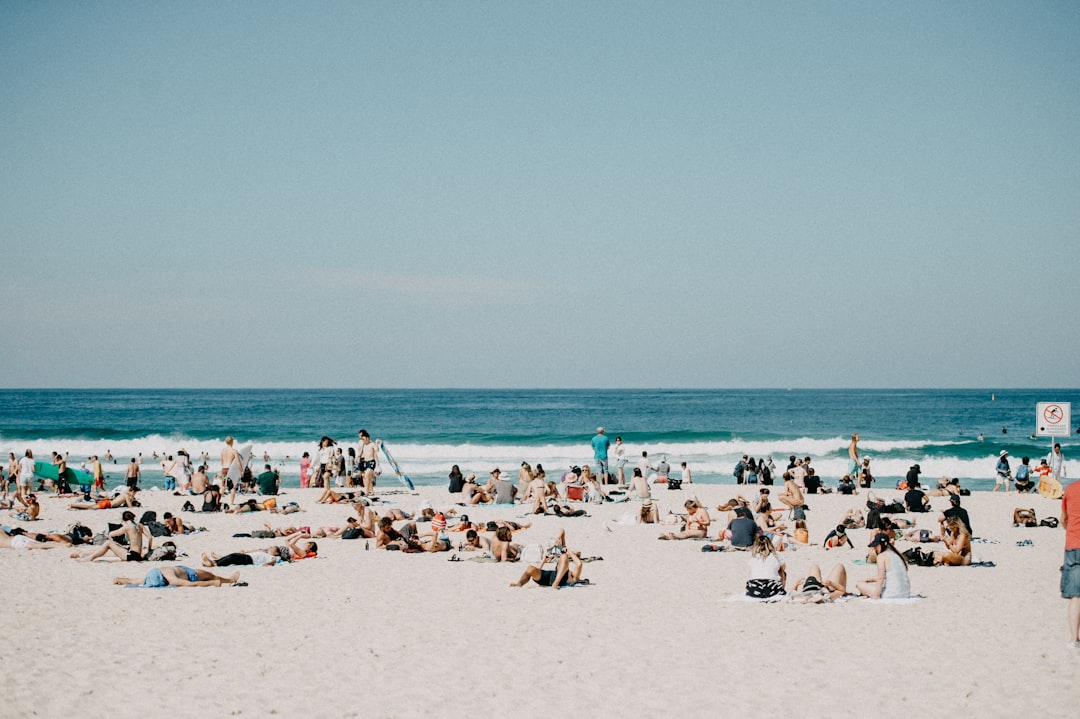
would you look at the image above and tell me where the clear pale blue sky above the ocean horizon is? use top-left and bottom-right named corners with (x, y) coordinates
top-left (0, 1), bottom-right (1080, 388)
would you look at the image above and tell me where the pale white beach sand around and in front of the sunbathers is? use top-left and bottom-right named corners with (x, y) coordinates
top-left (0, 485), bottom-right (1080, 717)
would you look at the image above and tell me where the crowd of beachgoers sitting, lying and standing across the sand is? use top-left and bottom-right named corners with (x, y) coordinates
top-left (0, 428), bottom-right (1080, 647)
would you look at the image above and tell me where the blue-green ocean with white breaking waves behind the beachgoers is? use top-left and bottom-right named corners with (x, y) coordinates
top-left (0, 390), bottom-right (1080, 490)
